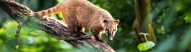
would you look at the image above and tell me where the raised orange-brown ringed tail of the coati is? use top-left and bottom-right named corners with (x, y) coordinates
top-left (30, 4), bottom-right (62, 17)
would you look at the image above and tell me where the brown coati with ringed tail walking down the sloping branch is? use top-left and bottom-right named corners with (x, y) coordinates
top-left (31, 0), bottom-right (119, 41)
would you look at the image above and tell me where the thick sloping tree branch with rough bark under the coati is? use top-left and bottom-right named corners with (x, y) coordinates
top-left (0, 0), bottom-right (115, 52)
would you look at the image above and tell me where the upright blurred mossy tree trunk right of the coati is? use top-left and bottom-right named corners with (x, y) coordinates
top-left (134, 0), bottom-right (157, 43)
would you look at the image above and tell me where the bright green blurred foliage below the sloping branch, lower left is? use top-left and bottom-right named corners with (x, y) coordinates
top-left (0, 21), bottom-right (73, 52)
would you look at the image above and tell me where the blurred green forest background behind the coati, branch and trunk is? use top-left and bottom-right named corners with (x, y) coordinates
top-left (0, 0), bottom-right (191, 52)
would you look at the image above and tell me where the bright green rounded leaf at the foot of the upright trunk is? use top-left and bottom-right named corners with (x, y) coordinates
top-left (138, 41), bottom-right (155, 51)
